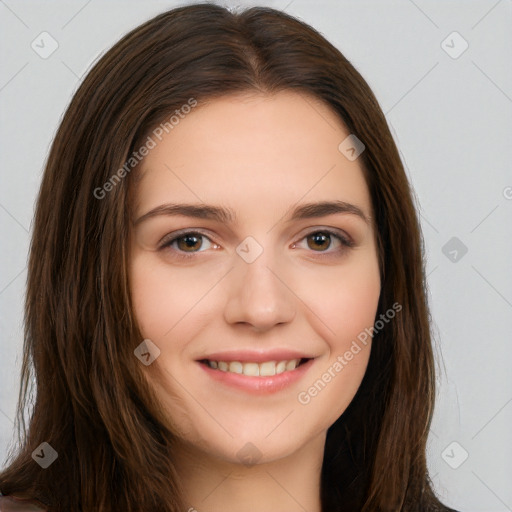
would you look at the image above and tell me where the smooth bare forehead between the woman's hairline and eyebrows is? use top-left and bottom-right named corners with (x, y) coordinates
top-left (134, 91), bottom-right (371, 216)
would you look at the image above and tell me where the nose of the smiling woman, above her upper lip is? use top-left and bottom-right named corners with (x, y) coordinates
top-left (224, 251), bottom-right (296, 332)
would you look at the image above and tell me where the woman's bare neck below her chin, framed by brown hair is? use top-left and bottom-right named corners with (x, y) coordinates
top-left (176, 432), bottom-right (325, 512)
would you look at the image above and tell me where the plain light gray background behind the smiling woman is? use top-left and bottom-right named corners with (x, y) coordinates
top-left (0, 0), bottom-right (512, 512)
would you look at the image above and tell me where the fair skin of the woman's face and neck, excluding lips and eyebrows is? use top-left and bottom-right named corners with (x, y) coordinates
top-left (129, 91), bottom-right (381, 512)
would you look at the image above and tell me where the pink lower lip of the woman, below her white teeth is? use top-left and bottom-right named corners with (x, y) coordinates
top-left (197, 359), bottom-right (314, 394)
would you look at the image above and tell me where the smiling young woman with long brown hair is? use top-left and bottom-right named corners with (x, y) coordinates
top-left (0, 4), bottom-right (460, 512)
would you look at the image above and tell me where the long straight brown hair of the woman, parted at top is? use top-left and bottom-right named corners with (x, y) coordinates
top-left (0, 4), bottom-right (456, 512)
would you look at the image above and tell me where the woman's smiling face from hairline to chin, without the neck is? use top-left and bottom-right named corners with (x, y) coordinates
top-left (129, 92), bottom-right (380, 463)
